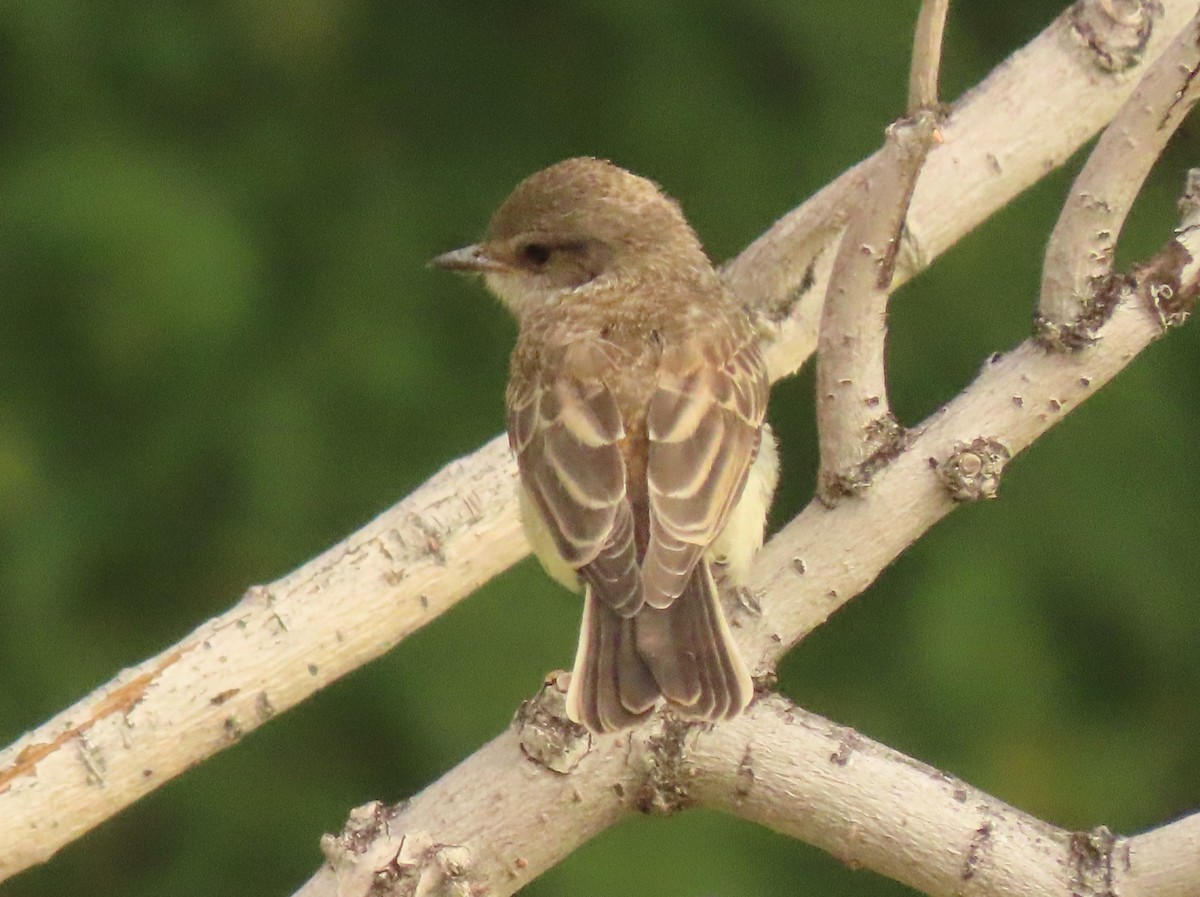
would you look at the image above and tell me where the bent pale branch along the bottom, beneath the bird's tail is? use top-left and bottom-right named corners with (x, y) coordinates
top-left (295, 686), bottom-right (1200, 897)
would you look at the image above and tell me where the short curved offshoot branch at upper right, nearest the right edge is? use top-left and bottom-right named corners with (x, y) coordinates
top-left (1039, 13), bottom-right (1200, 348)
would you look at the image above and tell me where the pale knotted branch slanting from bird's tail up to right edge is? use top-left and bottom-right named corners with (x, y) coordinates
top-left (737, 163), bottom-right (1200, 672)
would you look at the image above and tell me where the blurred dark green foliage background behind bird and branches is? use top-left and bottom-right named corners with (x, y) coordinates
top-left (0, 0), bottom-right (1200, 897)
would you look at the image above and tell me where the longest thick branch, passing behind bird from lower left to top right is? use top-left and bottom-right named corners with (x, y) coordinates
top-left (0, 0), bottom-right (1194, 880)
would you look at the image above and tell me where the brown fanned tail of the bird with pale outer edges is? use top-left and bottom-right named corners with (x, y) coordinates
top-left (566, 560), bottom-right (754, 732)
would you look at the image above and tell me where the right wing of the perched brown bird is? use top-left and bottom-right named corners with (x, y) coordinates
top-left (642, 327), bottom-right (770, 608)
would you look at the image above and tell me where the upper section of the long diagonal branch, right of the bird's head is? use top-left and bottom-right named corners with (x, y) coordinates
top-left (724, 0), bottom-right (1180, 379)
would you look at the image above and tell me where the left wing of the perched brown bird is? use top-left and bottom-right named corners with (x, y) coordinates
top-left (506, 339), bottom-right (642, 616)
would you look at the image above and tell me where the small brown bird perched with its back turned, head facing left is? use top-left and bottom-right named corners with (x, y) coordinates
top-left (431, 158), bottom-right (778, 733)
